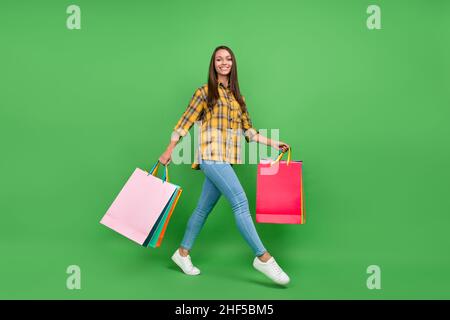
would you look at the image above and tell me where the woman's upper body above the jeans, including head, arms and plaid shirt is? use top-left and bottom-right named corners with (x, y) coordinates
top-left (159, 46), bottom-right (289, 170)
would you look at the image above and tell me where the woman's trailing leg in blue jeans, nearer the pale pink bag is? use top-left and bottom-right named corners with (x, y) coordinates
top-left (181, 176), bottom-right (221, 251)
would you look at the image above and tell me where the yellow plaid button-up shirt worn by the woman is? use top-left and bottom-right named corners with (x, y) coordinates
top-left (174, 82), bottom-right (259, 170)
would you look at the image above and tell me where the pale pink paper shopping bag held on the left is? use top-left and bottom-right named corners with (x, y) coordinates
top-left (100, 161), bottom-right (180, 245)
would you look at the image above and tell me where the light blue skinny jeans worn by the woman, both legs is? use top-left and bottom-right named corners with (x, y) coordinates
top-left (181, 160), bottom-right (266, 256)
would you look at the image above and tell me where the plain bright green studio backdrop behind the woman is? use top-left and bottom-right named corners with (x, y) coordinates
top-left (0, 0), bottom-right (450, 299)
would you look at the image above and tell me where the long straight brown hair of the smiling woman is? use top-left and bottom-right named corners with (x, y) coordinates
top-left (207, 46), bottom-right (247, 113)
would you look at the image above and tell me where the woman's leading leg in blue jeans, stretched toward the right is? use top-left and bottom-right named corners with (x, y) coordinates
top-left (201, 162), bottom-right (266, 256)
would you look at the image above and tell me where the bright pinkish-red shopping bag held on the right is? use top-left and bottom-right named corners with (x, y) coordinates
top-left (256, 149), bottom-right (306, 224)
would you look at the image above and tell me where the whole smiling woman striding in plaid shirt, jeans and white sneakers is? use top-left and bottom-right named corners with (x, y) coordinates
top-left (159, 46), bottom-right (290, 285)
